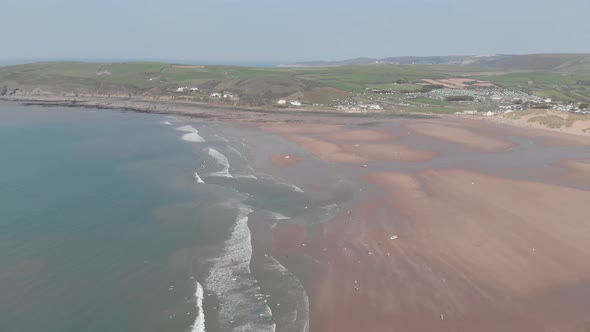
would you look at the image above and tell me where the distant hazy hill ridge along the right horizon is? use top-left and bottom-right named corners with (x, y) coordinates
top-left (282, 54), bottom-right (590, 72)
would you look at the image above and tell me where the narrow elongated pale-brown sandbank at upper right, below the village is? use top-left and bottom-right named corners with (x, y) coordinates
top-left (406, 122), bottom-right (512, 151)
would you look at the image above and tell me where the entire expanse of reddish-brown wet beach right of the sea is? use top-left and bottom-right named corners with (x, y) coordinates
top-left (262, 119), bottom-right (590, 332)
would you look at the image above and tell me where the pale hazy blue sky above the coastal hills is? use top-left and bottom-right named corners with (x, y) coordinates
top-left (0, 0), bottom-right (590, 63)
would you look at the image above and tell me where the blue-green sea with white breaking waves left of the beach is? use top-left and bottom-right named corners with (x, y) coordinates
top-left (0, 103), bottom-right (332, 332)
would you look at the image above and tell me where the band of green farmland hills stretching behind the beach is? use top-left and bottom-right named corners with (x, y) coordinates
top-left (0, 62), bottom-right (590, 112)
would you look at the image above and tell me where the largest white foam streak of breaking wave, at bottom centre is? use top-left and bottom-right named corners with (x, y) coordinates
top-left (205, 202), bottom-right (276, 332)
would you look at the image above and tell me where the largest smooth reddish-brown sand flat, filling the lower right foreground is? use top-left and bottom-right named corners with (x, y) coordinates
top-left (307, 169), bottom-right (590, 332)
